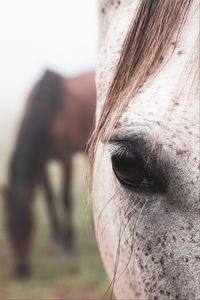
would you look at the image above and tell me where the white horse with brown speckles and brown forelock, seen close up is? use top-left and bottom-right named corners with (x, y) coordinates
top-left (88, 0), bottom-right (200, 300)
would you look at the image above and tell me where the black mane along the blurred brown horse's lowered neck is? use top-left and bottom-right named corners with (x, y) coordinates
top-left (10, 70), bottom-right (63, 182)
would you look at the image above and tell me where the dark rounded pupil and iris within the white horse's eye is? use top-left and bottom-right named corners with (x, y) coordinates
top-left (112, 153), bottom-right (145, 184)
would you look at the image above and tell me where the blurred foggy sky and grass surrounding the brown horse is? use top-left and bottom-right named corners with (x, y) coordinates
top-left (0, 0), bottom-right (108, 299)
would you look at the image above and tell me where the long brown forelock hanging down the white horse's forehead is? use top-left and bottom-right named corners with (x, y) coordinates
top-left (88, 0), bottom-right (193, 182)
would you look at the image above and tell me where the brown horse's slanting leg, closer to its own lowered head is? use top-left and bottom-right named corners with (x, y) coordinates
top-left (43, 172), bottom-right (61, 239)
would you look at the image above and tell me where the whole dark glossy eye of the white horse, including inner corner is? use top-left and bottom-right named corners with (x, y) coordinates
top-left (111, 152), bottom-right (155, 189)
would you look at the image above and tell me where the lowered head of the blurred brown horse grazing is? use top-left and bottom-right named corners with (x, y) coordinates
top-left (2, 183), bottom-right (33, 277)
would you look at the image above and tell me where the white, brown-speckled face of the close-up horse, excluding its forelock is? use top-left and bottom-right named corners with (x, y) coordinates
top-left (93, 0), bottom-right (200, 299)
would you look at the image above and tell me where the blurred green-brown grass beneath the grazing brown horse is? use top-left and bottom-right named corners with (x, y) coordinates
top-left (0, 126), bottom-right (108, 300)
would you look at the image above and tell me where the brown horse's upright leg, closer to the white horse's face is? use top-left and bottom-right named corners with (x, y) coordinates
top-left (63, 157), bottom-right (74, 250)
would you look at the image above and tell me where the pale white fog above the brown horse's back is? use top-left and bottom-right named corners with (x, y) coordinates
top-left (0, 0), bottom-right (97, 120)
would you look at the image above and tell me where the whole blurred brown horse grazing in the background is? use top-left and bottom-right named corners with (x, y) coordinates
top-left (4, 70), bottom-right (96, 277)
